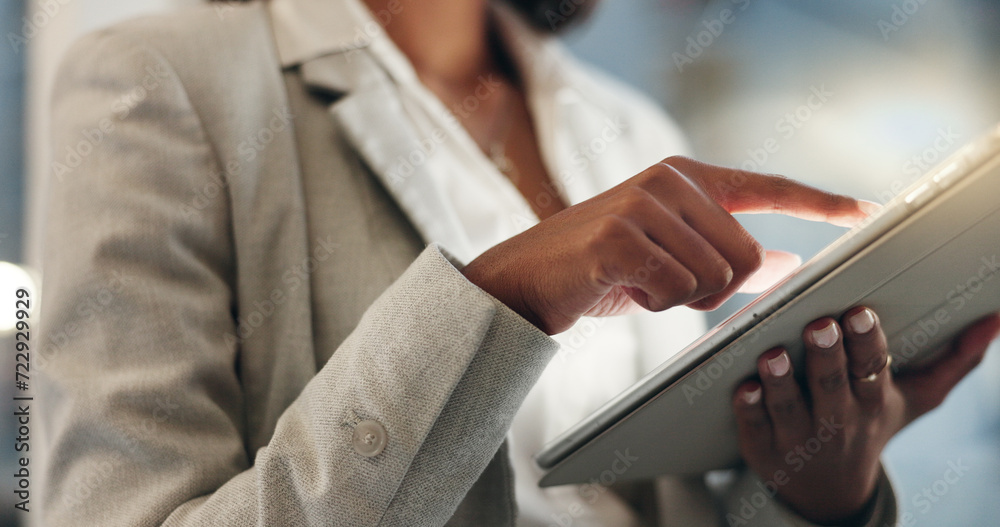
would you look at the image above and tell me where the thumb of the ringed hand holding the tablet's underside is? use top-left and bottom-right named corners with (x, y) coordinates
top-left (896, 314), bottom-right (1000, 423)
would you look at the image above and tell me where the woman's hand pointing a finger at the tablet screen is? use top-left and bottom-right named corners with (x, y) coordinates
top-left (462, 157), bottom-right (872, 334)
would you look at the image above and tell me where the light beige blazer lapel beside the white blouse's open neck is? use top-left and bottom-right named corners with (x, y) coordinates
top-left (300, 49), bottom-right (471, 261)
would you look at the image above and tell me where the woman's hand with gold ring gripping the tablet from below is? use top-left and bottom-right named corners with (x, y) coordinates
top-left (733, 307), bottom-right (1000, 524)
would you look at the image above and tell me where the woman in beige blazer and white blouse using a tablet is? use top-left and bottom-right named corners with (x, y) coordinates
top-left (39, 0), bottom-right (1000, 526)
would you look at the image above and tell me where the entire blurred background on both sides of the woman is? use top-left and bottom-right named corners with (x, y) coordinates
top-left (0, 0), bottom-right (1000, 526)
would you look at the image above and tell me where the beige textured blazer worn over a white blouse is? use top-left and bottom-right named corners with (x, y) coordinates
top-left (33, 0), bottom-right (894, 526)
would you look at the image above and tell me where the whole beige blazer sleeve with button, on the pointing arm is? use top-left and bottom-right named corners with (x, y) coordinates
top-left (36, 32), bottom-right (557, 527)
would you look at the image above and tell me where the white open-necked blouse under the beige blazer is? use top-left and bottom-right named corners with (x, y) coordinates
top-left (340, 0), bottom-right (705, 526)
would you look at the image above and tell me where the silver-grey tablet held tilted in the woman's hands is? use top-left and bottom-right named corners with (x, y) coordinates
top-left (535, 127), bottom-right (1000, 487)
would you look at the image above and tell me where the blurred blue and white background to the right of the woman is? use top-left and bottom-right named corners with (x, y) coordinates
top-left (567, 0), bottom-right (1000, 527)
